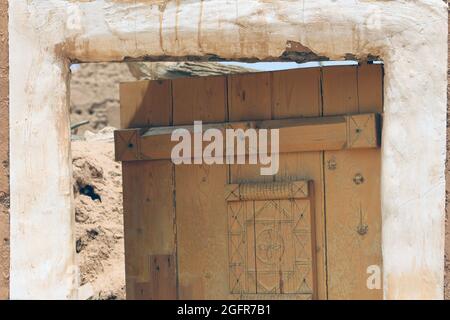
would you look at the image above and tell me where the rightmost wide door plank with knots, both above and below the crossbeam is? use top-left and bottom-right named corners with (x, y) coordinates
top-left (323, 63), bottom-right (382, 299)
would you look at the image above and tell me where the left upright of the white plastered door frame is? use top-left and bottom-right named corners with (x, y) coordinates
top-left (9, 1), bottom-right (77, 299)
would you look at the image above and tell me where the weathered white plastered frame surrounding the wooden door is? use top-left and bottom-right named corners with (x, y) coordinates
top-left (9, 0), bottom-right (447, 299)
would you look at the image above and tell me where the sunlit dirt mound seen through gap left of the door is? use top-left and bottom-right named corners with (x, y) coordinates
top-left (72, 129), bottom-right (125, 299)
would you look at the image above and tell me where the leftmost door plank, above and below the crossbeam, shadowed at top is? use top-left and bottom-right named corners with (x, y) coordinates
top-left (120, 81), bottom-right (176, 299)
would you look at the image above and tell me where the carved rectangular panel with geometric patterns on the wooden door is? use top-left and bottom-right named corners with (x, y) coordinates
top-left (226, 181), bottom-right (315, 298)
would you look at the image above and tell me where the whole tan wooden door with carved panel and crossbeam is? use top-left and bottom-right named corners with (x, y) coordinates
top-left (115, 65), bottom-right (382, 299)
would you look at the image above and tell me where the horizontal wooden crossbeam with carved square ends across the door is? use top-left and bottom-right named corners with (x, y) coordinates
top-left (114, 113), bottom-right (381, 161)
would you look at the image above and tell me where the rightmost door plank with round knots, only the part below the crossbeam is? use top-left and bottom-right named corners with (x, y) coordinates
top-left (325, 149), bottom-right (383, 299)
